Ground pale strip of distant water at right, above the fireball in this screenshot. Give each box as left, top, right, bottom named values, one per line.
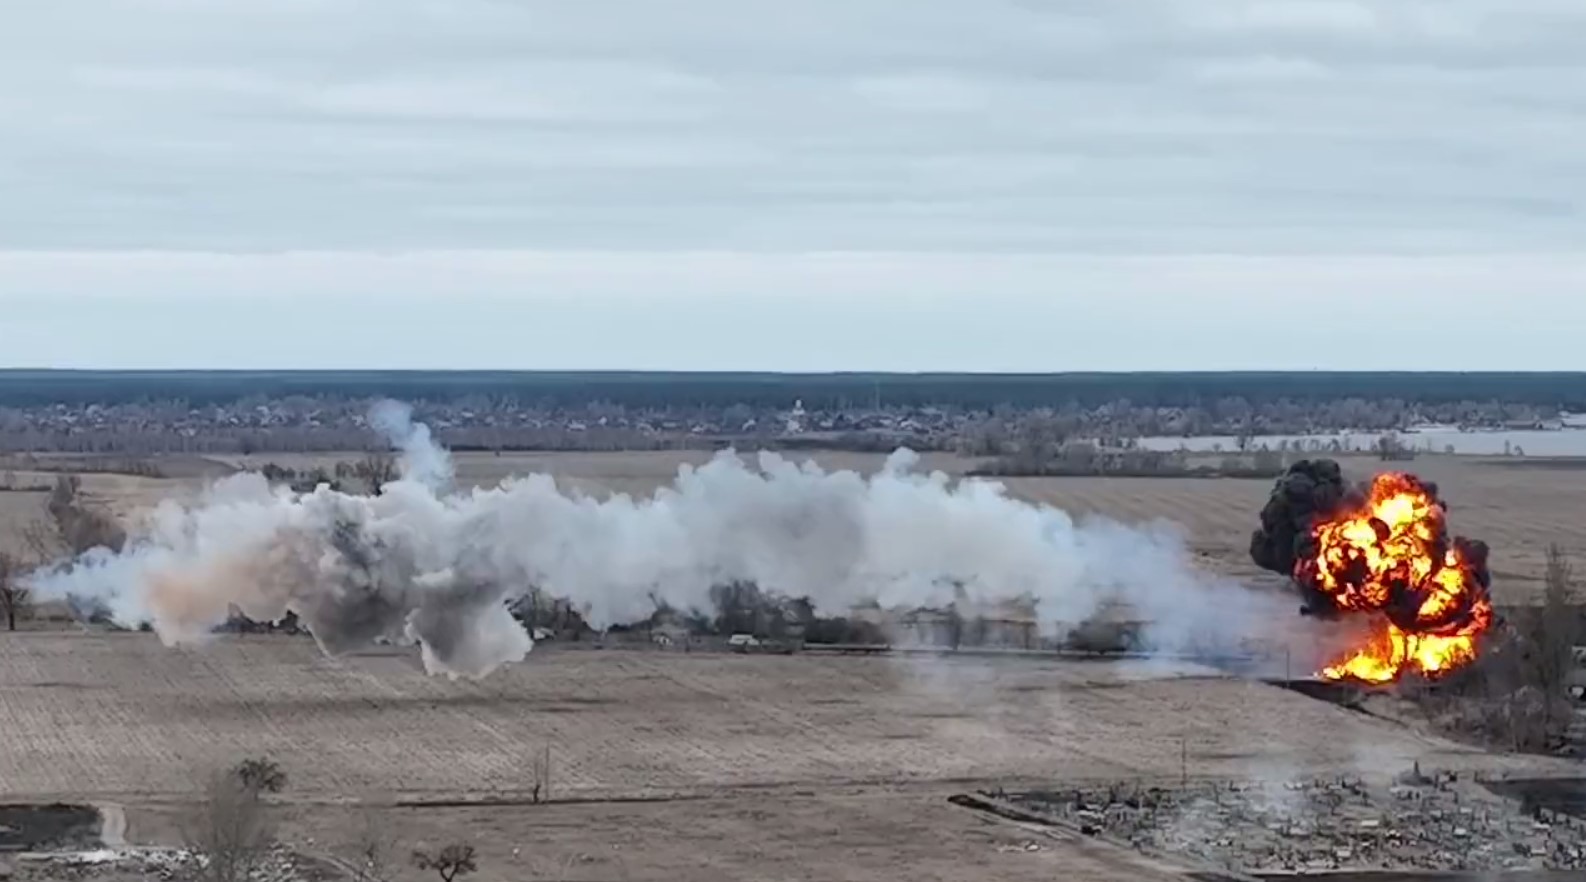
left=1139, top=428, right=1586, bottom=457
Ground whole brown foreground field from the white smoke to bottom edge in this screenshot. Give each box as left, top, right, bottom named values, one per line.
left=0, top=633, right=1562, bottom=882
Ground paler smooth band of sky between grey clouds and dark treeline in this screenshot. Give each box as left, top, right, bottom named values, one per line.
left=0, top=249, right=1586, bottom=371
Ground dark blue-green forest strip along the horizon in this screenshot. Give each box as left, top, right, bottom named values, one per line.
left=9, top=370, right=1586, bottom=411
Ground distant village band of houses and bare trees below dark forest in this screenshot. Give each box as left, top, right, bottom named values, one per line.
left=0, top=395, right=1565, bottom=457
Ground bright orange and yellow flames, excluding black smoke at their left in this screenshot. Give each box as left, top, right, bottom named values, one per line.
left=1296, top=473, right=1492, bottom=684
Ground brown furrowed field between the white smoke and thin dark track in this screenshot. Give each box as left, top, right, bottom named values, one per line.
left=0, top=633, right=1560, bottom=801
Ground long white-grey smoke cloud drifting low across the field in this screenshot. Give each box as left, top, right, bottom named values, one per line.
left=18, top=403, right=1293, bottom=676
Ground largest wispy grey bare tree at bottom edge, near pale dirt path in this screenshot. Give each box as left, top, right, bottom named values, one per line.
left=182, top=769, right=274, bottom=882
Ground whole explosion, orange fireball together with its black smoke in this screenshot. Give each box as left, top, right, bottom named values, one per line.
left=1251, top=460, right=1492, bottom=684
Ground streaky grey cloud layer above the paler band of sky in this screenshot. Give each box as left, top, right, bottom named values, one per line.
left=0, top=0, right=1586, bottom=252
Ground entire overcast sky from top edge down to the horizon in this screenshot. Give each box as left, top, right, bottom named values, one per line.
left=0, top=0, right=1586, bottom=371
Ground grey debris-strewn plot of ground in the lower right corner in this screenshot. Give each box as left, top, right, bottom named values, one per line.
left=1004, top=768, right=1586, bottom=874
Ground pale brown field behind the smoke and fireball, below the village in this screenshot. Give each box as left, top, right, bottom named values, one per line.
left=0, top=451, right=1586, bottom=603
